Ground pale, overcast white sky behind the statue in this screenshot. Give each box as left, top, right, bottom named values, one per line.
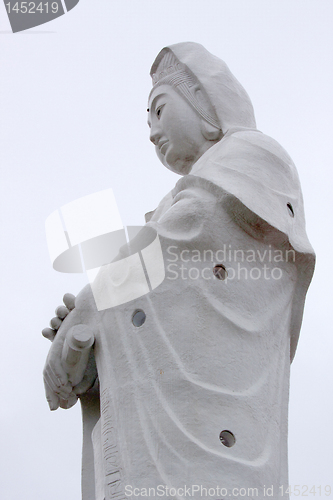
left=0, top=0, right=333, bottom=500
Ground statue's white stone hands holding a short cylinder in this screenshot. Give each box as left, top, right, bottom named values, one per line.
left=42, top=287, right=97, bottom=410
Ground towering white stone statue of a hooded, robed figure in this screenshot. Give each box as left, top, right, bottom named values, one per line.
left=44, top=43, right=314, bottom=500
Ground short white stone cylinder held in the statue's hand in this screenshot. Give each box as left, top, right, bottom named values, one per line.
left=62, top=325, right=95, bottom=387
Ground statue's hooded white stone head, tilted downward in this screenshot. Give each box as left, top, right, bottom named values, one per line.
left=148, top=43, right=255, bottom=175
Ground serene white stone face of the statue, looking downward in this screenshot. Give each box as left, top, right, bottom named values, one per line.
left=148, top=85, right=212, bottom=175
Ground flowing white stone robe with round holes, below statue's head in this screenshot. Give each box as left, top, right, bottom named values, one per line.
left=80, top=127, right=314, bottom=500
